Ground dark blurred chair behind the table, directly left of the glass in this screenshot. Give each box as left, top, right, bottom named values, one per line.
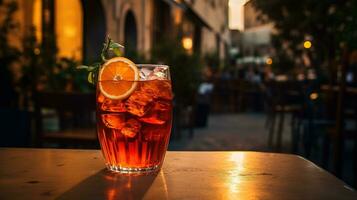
left=34, top=92, right=99, bottom=148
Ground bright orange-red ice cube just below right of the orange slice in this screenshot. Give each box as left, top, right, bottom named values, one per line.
left=125, top=90, right=153, bottom=117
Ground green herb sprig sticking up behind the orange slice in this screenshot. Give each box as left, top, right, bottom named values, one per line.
left=77, top=36, right=124, bottom=84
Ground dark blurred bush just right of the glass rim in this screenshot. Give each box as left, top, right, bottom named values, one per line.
left=150, top=39, right=202, bottom=105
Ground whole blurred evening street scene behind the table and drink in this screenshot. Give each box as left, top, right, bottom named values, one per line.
left=0, top=0, right=357, bottom=188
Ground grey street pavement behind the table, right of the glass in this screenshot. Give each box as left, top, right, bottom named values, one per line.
left=169, top=113, right=290, bottom=151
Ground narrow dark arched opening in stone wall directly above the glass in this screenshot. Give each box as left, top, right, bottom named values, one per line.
left=124, top=11, right=138, bottom=55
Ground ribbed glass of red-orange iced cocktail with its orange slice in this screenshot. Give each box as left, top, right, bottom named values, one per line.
left=97, top=57, right=172, bottom=173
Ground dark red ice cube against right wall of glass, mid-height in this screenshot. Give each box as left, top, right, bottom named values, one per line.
left=139, top=100, right=171, bottom=125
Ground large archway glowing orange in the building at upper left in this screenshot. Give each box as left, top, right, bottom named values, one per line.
left=32, top=0, right=106, bottom=63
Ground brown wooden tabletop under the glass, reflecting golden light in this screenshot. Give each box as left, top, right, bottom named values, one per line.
left=0, top=149, right=357, bottom=200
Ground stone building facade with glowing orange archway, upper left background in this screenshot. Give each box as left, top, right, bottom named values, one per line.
left=12, top=0, right=229, bottom=61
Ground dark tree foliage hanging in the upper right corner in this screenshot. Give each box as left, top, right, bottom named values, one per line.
left=252, top=0, right=357, bottom=80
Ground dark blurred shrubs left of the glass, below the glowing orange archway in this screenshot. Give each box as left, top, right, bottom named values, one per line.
left=20, top=28, right=91, bottom=93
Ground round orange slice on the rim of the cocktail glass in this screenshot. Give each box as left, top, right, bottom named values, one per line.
left=98, top=57, right=139, bottom=100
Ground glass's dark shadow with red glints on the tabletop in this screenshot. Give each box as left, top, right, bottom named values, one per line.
left=57, top=169, right=158, bottom=200
